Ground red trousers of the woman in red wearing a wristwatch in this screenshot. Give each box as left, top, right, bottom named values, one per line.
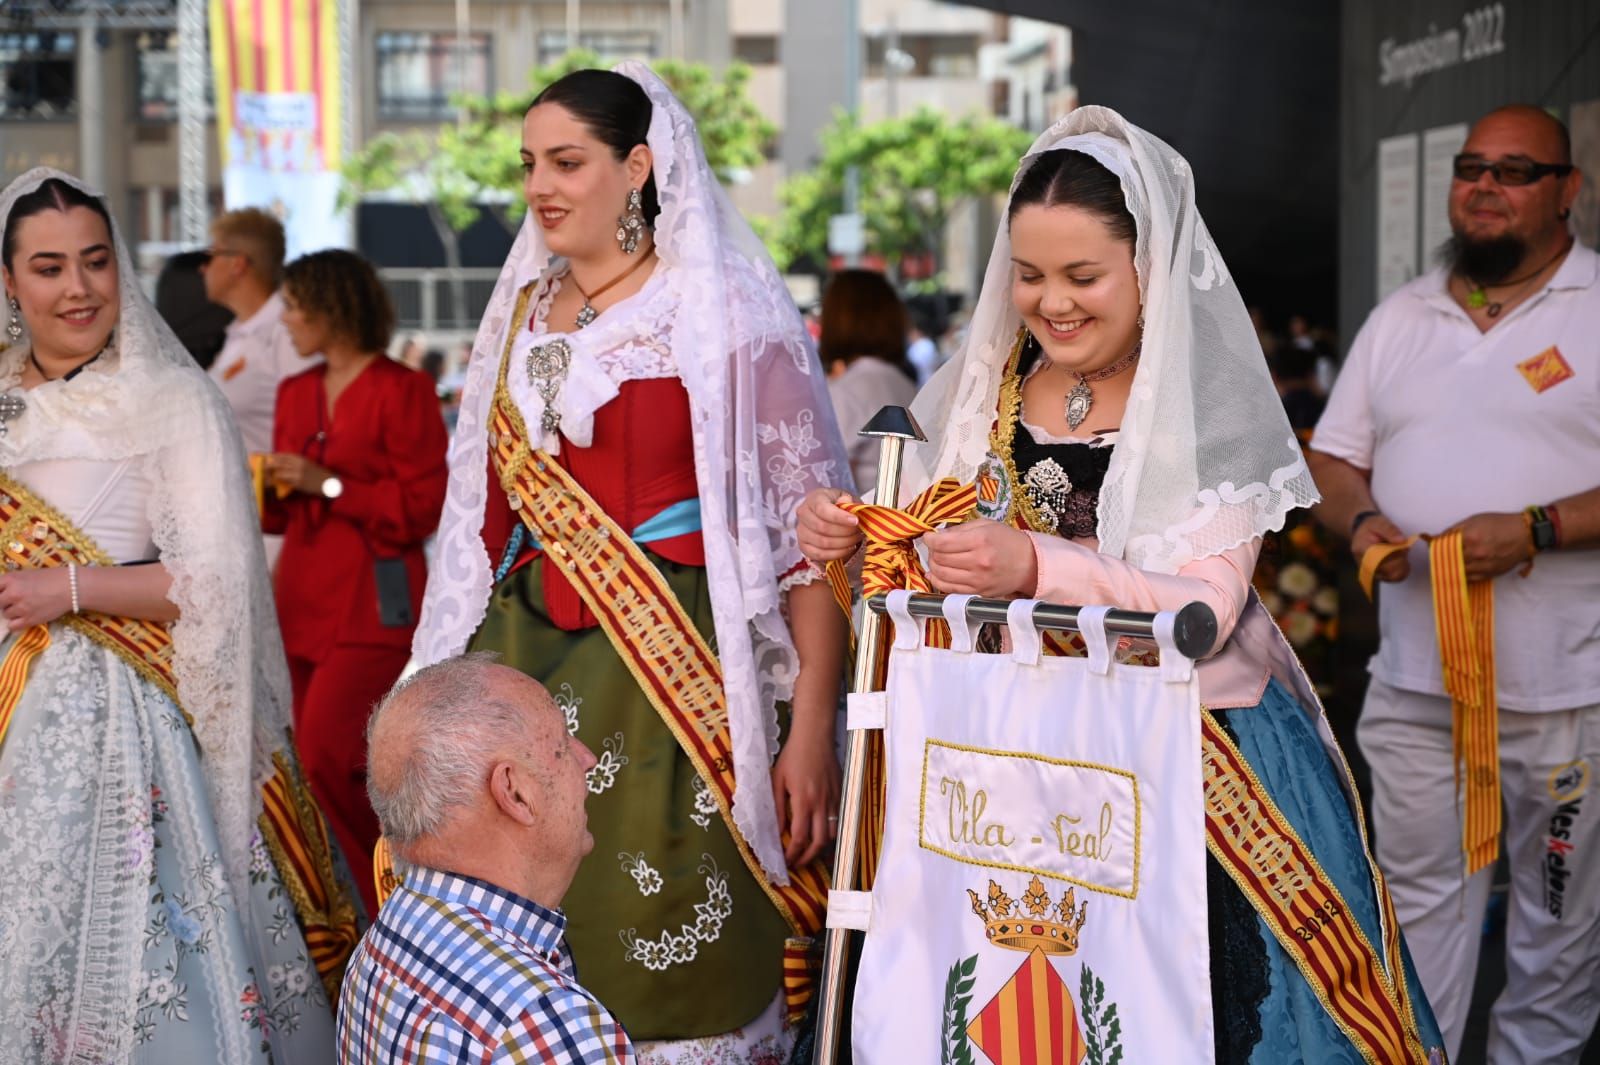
left=290, top=646, right=410, bottom=916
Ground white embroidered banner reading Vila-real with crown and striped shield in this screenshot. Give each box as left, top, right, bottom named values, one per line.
left=851, top=598, right=1213, bottom=1065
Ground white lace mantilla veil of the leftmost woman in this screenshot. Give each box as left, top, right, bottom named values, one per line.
left=0, top=168, right=290, bottom=914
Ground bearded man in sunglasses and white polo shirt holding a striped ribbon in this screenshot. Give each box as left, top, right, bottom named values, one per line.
left=1309, top=106, right=1600, bottom=1065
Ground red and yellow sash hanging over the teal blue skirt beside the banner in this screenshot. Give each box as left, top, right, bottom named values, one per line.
left=1200, top=713, right=1427, bottom=1065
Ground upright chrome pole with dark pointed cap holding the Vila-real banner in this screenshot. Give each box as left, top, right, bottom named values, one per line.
left=811, top=406, right=926, bottom=1065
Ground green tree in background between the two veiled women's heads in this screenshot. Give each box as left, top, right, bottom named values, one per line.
left=762, top=107, right=1032, bottom=269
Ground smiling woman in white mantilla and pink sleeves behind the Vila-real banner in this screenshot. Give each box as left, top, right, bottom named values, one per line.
left=800, top=107, right=1440, bottom=1065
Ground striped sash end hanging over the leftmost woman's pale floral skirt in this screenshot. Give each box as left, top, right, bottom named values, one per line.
left=256, top=741, right=362, bottom=1001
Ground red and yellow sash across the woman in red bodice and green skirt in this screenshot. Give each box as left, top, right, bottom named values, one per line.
left=490, top=289, right=827, bottom=1014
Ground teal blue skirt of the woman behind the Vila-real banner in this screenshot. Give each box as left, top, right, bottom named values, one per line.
left=1206, top=680, right=1445, bottom=1065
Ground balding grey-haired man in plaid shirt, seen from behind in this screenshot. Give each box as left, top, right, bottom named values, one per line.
left=339, top=656, right=635, bottom=1065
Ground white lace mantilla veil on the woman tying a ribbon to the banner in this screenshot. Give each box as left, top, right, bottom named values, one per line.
left=902, top=107, right=1318, bottom=572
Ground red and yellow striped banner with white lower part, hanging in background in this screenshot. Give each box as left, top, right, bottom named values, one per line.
left=210, top=0, right=347, bottom=252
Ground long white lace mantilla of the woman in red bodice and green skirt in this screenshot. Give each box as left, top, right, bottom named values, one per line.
left=413, top=61, right=850, bottom=883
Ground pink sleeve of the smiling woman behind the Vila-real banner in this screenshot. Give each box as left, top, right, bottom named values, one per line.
left=1029, top=533, right=1261, bottom=657
